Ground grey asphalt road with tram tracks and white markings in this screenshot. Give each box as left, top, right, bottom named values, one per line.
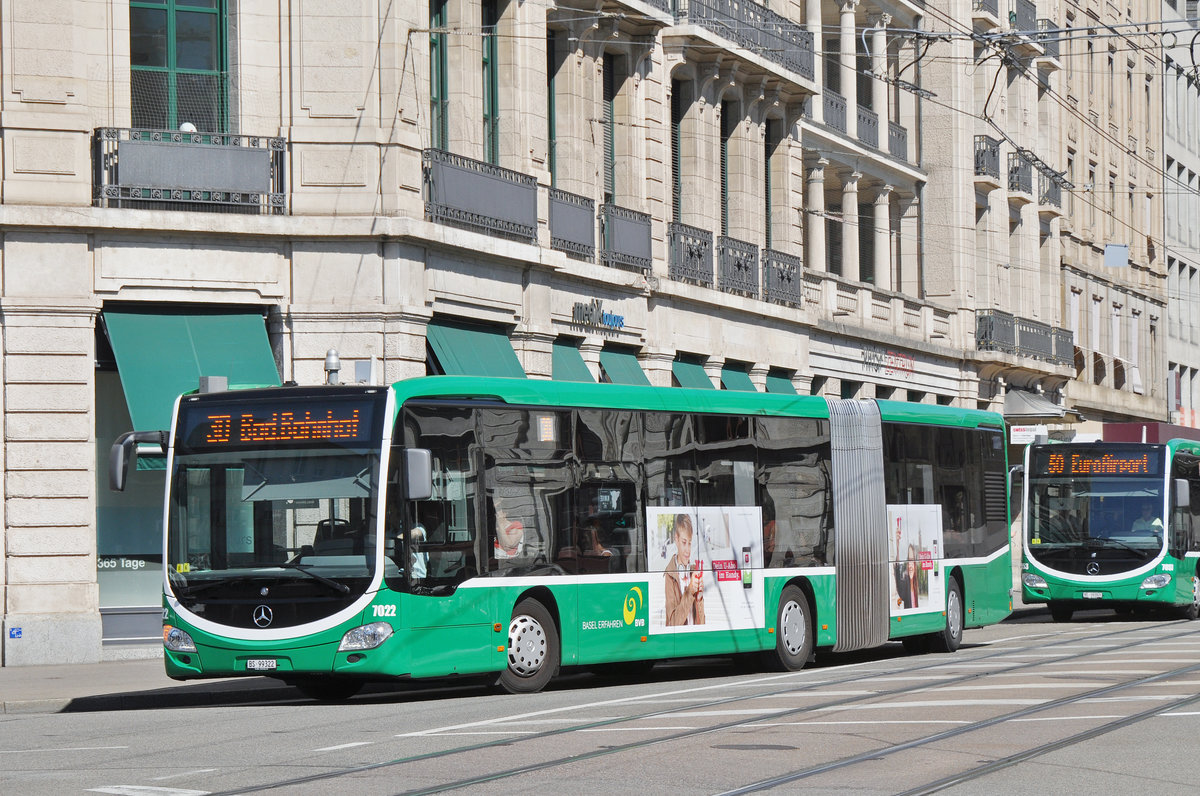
left=0, top=612, right=1200, bottom=796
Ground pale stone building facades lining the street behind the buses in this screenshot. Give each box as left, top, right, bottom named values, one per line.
left=0, top=0, right=1164, bottom=665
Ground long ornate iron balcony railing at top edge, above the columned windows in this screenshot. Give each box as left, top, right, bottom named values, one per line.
left=673, top=0, right=816, bottom=80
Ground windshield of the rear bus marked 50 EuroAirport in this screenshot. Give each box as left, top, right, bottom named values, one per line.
left=1025, top=445, right=1165, bottom=573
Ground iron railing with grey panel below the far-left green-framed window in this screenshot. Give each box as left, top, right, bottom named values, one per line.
left=91, top=127, right=287, bottom=215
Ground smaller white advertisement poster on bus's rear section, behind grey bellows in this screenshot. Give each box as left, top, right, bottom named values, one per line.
left=888, top=504, right=946, bottom=616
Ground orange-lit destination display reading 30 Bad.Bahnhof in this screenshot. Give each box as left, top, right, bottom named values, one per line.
left=181, top=401, right=374, bottom=450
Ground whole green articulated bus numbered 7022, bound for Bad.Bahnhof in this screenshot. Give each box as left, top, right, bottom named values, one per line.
left=112, top=376, right=1012, bottom=699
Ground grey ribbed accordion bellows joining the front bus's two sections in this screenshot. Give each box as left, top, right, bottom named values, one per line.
left=827, top=399, right=890, bottom=652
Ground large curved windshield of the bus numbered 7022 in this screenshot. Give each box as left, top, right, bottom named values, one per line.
left=166, top=395, right=379, bottom=628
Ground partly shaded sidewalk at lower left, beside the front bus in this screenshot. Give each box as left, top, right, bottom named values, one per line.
left=0, top=654, right=302, bottom=713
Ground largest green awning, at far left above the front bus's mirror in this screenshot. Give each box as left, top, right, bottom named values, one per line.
left=103, top=305, right=280, bottom=431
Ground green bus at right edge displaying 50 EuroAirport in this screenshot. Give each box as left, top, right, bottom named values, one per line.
left=1021, top=424, right=1200, bottom=622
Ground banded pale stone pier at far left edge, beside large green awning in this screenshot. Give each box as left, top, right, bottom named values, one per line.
left=0, top=298, right=102, bottom=666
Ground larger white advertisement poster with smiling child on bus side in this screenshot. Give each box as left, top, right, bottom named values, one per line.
left=646, top=505, right=764, bottom=633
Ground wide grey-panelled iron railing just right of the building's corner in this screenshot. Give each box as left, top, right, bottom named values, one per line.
left=422, top=149, right=538, bottom=243
